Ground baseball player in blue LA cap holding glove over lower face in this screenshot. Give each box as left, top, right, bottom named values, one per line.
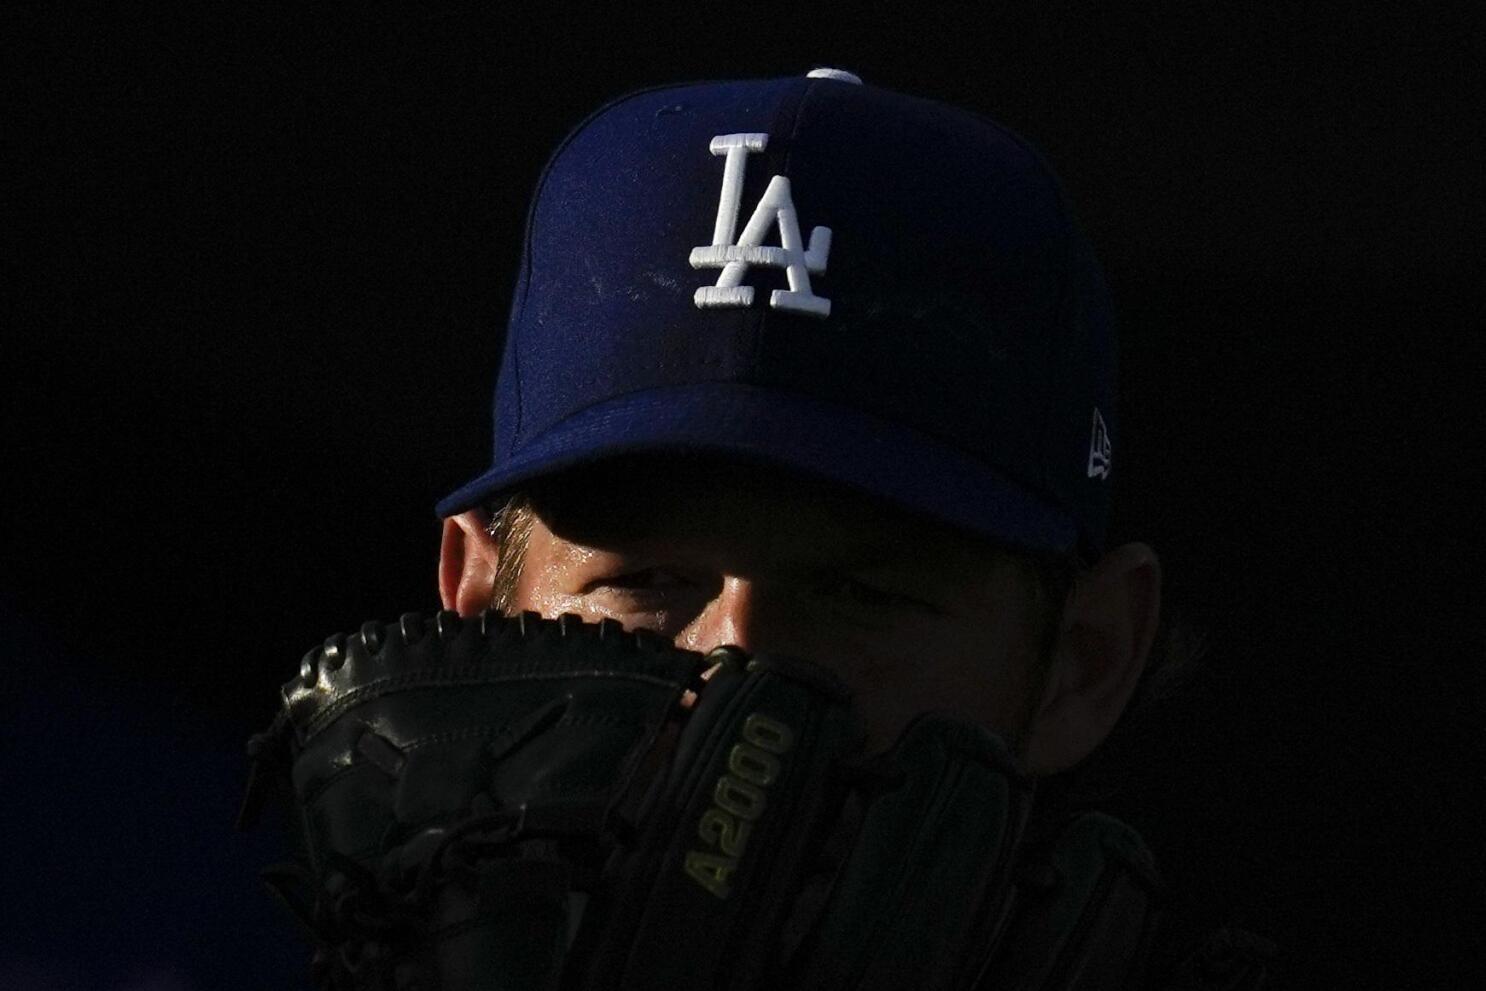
left=237, top=68, right=1265, bottom=988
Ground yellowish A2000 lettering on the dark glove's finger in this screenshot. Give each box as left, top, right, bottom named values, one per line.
left=687, top=712, right=795, bottom=899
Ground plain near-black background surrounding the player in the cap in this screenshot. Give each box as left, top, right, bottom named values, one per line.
left=0, top=0, right=1483, bottom=991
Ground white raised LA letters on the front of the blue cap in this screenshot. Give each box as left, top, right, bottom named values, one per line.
left=691, top=134, right=831, bottom=316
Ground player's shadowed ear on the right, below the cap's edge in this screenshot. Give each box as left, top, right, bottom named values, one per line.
left=1024, top=544, right=1161, bottom=774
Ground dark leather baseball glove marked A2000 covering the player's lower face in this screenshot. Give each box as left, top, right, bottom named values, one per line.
left=241, top=612, right=1262, bottom=991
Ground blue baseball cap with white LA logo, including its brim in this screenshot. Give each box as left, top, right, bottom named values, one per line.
left=438, top=70, right=1116, bottom=560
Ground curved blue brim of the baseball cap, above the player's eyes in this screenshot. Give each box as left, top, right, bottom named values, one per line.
left=437, top=383, right=1077, bottom=553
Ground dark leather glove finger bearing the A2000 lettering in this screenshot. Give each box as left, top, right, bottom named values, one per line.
left=574, top=657, right=862, bottom=990
